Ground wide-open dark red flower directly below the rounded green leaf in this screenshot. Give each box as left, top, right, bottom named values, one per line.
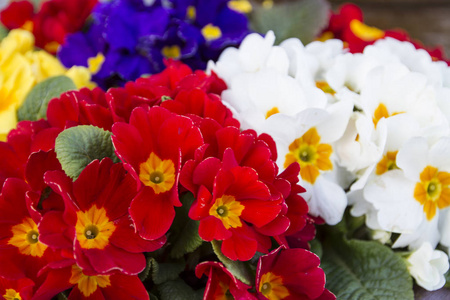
left=39, top=158, right=165, bottom=275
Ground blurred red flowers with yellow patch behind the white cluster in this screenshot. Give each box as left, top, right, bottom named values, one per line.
left=321, top=4, right=450, bottom=64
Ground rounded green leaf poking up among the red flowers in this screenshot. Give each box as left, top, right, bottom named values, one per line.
left=55, top=125, right=119, bottom=180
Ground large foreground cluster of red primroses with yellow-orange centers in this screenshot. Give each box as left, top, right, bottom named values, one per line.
left=0, top=62, right=335, bottom=300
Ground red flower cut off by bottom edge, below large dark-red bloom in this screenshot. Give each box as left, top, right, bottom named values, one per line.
left=33, top=264, right=149, bottom=300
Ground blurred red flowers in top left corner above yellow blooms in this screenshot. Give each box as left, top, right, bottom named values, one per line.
left=0, top=0, right=98, bottom=54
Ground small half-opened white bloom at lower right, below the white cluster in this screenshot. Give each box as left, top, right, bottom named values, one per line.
left=407, top=243, right=449, bottom=291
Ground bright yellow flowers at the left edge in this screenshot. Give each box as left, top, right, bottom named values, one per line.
left=0, top=29, right=95, bottom=141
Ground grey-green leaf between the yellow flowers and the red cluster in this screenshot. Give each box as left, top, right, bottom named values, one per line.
left=17, top=76, right=77, bottom=121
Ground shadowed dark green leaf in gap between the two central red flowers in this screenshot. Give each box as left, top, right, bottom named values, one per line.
left=169, top=193, right=203, bottom=258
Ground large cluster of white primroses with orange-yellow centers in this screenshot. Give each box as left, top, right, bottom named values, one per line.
left=208, top=32, right=450, bottom=289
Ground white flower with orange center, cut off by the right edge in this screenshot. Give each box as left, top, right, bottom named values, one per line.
left=364, top=137, right=450, bottom=248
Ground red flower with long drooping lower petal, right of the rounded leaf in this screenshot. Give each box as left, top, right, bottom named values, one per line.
left=112, top=107, right=203, bottom=239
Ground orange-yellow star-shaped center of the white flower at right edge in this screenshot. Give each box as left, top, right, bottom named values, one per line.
left=414, top=166, right=450, bottom=221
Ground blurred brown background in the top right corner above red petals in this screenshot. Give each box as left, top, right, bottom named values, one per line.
left=328, top=0, right=450, bottom=57
